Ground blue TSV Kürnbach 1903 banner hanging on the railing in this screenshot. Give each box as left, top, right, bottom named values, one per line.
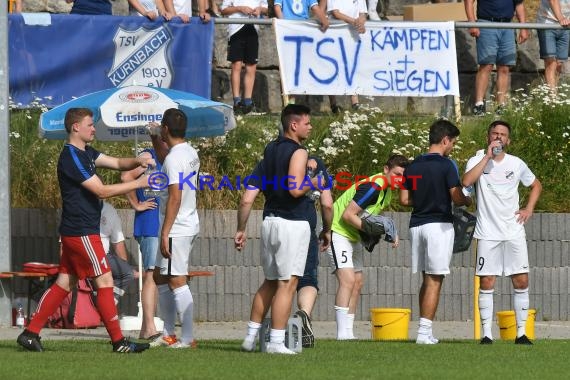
left=8, top=14, right=214, bottom=107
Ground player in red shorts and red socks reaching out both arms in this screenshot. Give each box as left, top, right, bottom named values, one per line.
left=17, top=108, right=154, bottom=353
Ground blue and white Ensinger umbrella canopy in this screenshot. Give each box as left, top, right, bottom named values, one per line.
left=39, top=86, right=236, bottom=141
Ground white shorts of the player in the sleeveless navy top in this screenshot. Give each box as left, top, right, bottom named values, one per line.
left=261, top=216, right=311, bottom=280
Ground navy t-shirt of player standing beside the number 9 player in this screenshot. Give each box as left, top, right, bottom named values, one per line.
left=404, top=153, right=461, bottom=227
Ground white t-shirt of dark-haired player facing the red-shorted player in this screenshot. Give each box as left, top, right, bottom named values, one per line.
left=159, top=143, right=200, bottom=237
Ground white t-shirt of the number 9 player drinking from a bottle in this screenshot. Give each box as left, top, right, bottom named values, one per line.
left=465, top=150, right=536, bottom=240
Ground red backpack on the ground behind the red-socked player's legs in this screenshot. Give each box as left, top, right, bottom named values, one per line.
left=47, top=280, right=101, bottom=329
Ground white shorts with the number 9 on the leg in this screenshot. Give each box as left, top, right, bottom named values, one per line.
left=475, top=238, right=529, bottom=276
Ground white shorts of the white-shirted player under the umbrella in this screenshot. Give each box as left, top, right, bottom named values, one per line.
left=155, top=235, right=196, bottom=276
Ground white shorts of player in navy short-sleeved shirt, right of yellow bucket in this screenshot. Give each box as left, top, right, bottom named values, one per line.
left=410, top=223, right=455, bottom=275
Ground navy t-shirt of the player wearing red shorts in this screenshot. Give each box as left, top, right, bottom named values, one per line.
left=57, top=144, right=103, bottom=236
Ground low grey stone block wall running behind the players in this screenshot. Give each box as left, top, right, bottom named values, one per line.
left=8, top=209, right=570, bottom=321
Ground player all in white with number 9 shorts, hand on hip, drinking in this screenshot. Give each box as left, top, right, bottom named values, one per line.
left=462, top=120, right=542, bottom=344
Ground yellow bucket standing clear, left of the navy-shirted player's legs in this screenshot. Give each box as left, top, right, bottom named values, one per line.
left=370, top=309, right=412, bottom=340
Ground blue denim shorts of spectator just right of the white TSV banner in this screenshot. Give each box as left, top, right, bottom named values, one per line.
left=477, top=20, right=517, bottom=66
